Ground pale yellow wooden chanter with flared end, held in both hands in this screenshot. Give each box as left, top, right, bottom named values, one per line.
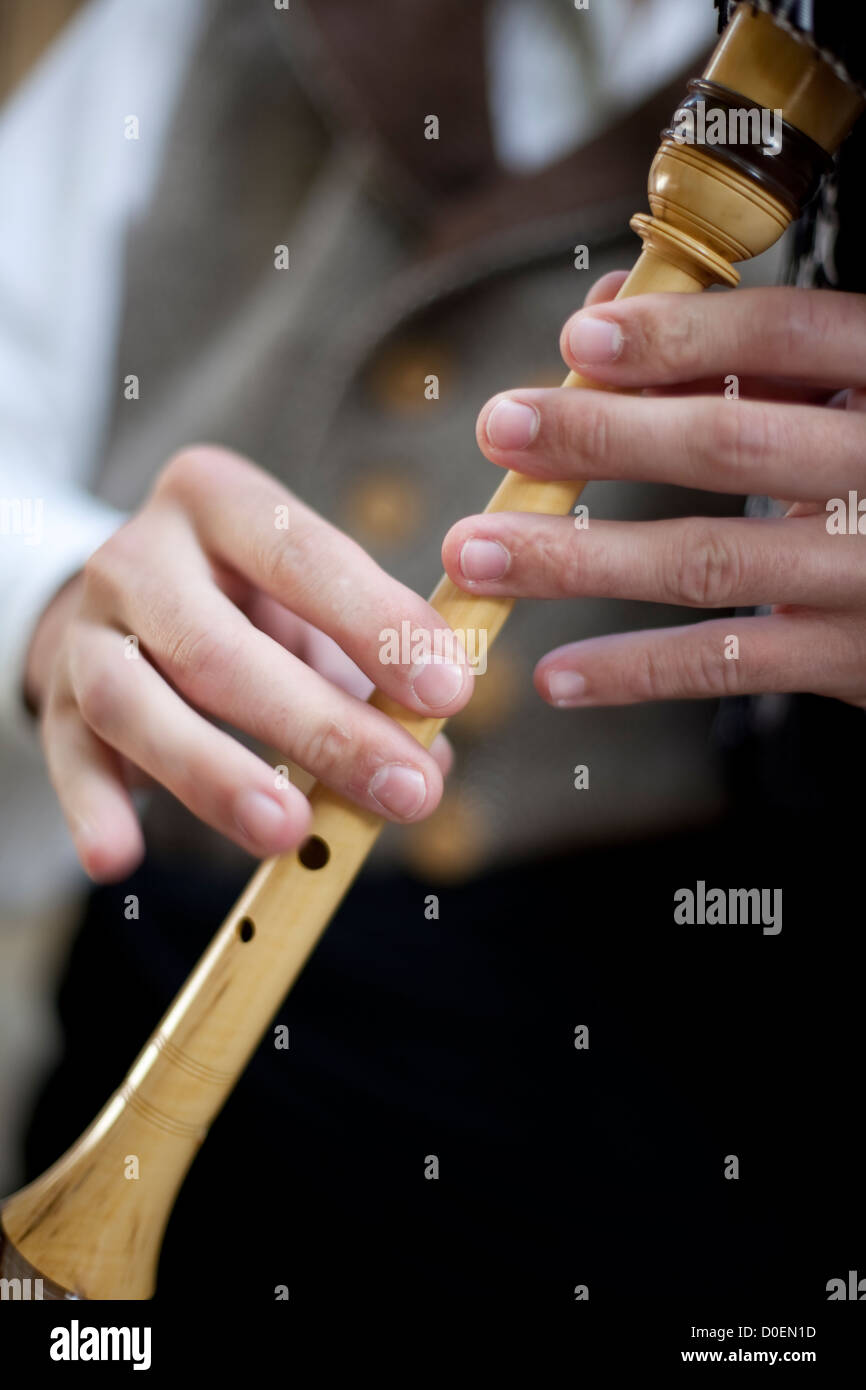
left=0, top=3, right=865, bottom=1298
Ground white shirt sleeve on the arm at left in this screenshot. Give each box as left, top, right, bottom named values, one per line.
left=0, top=0, right=207, bottom=910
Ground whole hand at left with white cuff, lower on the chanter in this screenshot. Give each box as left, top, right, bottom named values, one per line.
left=25, top=446, right=473, bottom=881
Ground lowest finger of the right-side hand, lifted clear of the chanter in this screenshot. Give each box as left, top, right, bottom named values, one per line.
left=534, top=612, right=866, bottom=709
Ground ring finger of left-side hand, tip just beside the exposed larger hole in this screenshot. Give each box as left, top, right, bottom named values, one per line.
left=70, top=627, right=310, bottom=858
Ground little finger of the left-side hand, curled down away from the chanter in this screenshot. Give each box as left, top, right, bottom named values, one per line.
left=42, top=696, right=145, bottom=883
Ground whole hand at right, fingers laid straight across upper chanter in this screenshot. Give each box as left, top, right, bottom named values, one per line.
left=442, top=272, right=866, bottom=706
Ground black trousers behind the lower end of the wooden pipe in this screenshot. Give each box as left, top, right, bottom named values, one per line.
left=26, top=816, right=863, bottom=1309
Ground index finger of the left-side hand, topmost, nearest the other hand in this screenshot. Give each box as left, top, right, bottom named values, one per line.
left=155, top=448, right=473, bottom=716
